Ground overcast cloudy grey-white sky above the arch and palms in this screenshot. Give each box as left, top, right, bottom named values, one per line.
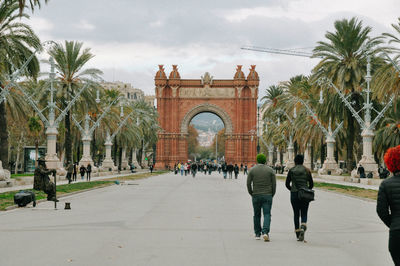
left=24, top=0, right=400, bottom=97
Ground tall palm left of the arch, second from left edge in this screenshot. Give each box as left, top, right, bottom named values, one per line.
left=49, top=41, right=102, bottom=161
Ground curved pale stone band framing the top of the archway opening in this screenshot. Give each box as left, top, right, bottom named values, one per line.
left=181, top=103, right=233, bottom=135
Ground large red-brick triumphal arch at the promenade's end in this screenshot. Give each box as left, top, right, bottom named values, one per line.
left=155, top=65, right=259, bottom=169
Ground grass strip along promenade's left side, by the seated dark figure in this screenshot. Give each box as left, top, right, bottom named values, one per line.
left=0, top=171, right=168, bottom=211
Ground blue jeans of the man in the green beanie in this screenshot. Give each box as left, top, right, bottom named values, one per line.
left=252, top=195, right=272, bottom=236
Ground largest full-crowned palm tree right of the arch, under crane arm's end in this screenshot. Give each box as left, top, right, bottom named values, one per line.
left=313, top=18, right=383, bottom=171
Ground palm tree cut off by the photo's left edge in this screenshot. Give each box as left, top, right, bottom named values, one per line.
left=0, top=1, right=41, bottom=169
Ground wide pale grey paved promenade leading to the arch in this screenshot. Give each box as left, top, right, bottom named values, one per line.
left=0, top=171, right=393, bottom=266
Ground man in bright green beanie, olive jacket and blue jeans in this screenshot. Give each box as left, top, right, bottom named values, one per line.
left=247, top=153, right=276, bottom=242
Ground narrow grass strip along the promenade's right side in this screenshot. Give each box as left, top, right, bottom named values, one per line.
left=277, top=177, right=378, bottom=200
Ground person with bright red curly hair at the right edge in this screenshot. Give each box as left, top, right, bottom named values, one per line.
left=376, top=145, right=400, bottom=266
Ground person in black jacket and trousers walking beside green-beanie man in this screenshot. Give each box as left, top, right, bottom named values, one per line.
left=285, top=154, right=314, bottom=241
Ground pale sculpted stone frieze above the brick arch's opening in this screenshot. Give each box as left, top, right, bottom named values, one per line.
left=179, top=86, right=235, bottom=98
